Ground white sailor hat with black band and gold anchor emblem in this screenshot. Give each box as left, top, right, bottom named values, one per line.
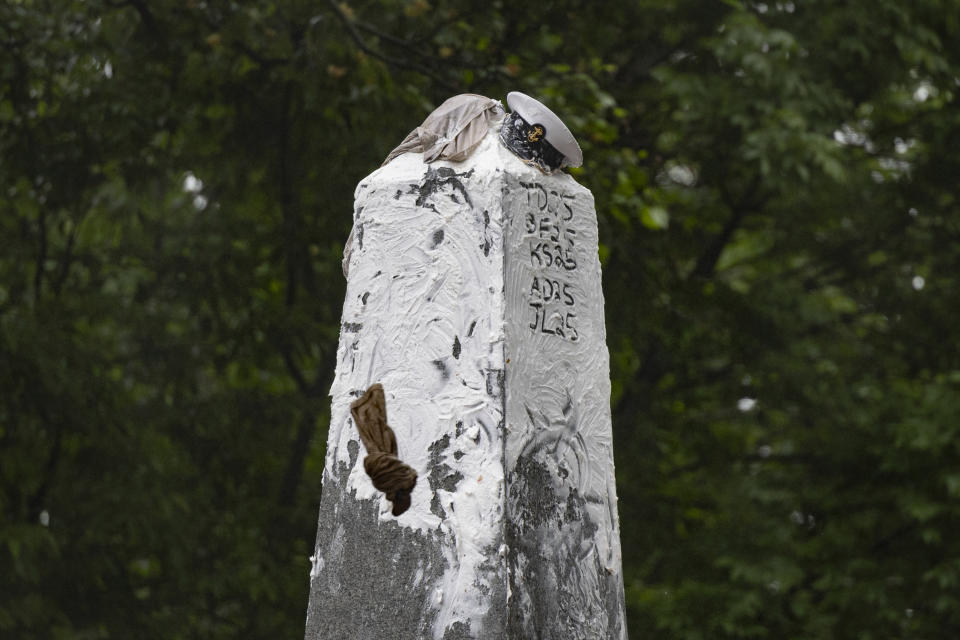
left=500, top=91, right=583, bottom=173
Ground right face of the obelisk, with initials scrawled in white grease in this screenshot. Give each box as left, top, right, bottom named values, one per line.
left=502, top=172, right=626, bottom=640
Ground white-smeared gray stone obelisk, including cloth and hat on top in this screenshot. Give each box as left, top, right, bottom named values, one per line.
left=306, top=93, right=626, bottom=640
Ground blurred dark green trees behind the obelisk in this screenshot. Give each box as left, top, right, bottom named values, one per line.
left=0, top=0, right=960, bottom=640
